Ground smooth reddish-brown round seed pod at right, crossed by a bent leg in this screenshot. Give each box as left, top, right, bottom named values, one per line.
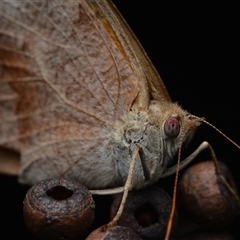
left=178, top=161, right=240, bottom=228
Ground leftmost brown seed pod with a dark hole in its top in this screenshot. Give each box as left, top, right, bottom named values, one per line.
left=23, top=178, right=95, bottom=240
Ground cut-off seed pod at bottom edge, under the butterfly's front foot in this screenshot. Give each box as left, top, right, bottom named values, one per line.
left=86, top=226, right=141, bottom=240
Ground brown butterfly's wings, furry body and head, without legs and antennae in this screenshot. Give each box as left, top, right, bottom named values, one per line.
left=0, top=1, right=204, bottom=189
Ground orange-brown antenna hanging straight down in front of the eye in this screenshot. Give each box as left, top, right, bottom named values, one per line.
left=165, top=131, right=183, bottom=240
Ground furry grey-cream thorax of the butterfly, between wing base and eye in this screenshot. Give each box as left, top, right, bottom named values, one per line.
left=113, top=101, right=180, bottom=189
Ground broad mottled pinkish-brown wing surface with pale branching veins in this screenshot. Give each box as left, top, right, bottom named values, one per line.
left=0, top=1, right=139, bottom=188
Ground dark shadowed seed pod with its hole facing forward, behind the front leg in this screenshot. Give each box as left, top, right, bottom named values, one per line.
left=110, top=187, right=176, bottom=240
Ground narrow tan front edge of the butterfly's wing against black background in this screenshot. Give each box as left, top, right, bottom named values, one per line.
left=89, top=0, right=171, bottom=110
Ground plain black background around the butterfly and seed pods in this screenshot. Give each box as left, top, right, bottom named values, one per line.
left=0, top=0, right=240, bottom=239
